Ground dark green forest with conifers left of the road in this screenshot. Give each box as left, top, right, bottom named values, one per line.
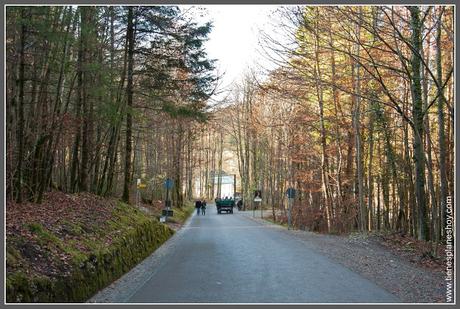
left=6, top=6, right=216, bottom=205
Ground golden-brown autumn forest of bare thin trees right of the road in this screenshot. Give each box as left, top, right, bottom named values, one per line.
left=215, top=6, right=454, bottom=243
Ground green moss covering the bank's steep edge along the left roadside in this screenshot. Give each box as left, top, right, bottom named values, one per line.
left=6, top=203, right=174, bottom=302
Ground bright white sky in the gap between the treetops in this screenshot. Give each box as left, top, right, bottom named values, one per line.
left=185, top=5, right=276, bottom=100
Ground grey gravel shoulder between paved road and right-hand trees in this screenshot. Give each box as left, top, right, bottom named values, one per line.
left=238, top=212, right=446, bottom=303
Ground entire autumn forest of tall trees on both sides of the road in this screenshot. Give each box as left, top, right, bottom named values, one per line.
left=5, top=6, right=455, bottom=243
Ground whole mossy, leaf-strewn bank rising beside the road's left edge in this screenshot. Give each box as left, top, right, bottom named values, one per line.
left=6, top=194, right=181, bottom=303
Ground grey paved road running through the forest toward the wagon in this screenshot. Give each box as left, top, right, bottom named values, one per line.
left=94, top=206, right=399, bottom=303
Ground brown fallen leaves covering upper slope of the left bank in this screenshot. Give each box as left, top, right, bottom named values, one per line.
left=6, top=191, right=124, bottom=277
